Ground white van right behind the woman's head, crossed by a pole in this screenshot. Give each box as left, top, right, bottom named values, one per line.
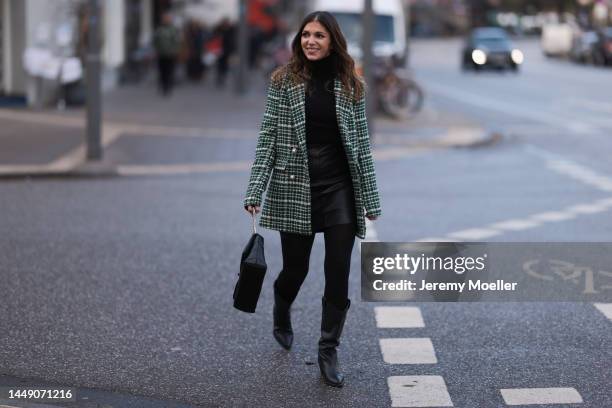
left=309, top=0, right=406, bottom=61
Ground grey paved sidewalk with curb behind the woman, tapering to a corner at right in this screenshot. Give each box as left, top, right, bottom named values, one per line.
left=0, top=76, right=496, bottom=178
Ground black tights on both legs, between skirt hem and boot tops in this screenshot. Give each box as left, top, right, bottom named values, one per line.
left=275, top=224, right=355, bottom=309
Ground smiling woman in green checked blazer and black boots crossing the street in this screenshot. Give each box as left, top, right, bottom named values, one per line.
left=244, top=11, right=381, bottom=387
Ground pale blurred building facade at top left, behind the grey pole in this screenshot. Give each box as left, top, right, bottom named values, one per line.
left=0, top=0, right=154, bottom=106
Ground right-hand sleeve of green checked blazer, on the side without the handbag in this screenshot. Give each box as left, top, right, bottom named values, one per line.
left=355, top=91, right=382, bottom=216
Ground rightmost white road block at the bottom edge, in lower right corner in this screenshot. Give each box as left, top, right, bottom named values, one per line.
left=500, top=388, right=584, bottom=405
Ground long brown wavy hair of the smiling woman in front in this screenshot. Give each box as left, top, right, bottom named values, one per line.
left=272, top=11, right=365, bottom=100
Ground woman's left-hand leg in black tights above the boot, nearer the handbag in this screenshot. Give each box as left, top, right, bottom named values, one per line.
left=275, top=232, right=314, bottom=303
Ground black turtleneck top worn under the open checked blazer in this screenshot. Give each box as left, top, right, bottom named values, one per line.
left=305, top=56, right=350, bottom=191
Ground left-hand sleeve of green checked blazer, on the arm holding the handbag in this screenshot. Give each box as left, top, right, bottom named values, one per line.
left=243, top=81, right=281, bottom=208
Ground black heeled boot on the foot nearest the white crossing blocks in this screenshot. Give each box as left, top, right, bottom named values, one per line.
left=318, top=298, right=351, bottom=387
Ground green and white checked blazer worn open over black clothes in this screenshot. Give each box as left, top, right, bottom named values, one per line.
left=244, top=74, right=381, bottom=239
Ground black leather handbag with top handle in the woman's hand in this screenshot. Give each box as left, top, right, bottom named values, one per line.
left=234, top=214, right=268, bottom=313
